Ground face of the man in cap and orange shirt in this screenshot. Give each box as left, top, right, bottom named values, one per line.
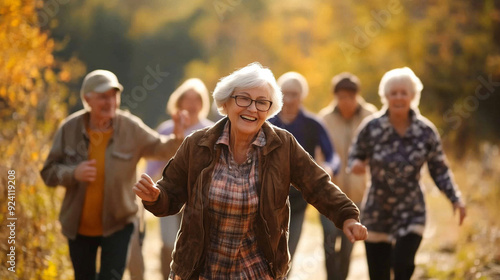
left=84, top=88, right=120, bottom=123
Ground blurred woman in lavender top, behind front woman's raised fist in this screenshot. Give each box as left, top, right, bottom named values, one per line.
left=146, top=78, right=214, bottom=279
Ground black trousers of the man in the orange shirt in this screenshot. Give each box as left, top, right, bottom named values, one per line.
left=68, top=223, right=134, bottom=280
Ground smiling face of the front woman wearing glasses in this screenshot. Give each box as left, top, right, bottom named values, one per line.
left=224, top=86, right=270, bottom=139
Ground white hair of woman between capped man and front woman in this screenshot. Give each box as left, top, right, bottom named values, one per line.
left=166, top=78, right=210, bottom=119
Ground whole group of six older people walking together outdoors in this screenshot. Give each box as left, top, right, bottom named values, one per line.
left=41, top=63, right=466, bottom=280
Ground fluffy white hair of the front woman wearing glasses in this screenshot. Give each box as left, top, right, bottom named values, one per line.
left=213, top=62, right=283, bottom=119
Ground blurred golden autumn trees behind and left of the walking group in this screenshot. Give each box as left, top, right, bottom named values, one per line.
left=0, top=0, right=500, bottom=279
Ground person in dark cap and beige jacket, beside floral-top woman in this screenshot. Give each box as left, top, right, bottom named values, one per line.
left=319, top=72, right=377, bottom=280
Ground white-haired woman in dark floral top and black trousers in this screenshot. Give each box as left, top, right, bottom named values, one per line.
left=349, top=67, right=466, bottom=280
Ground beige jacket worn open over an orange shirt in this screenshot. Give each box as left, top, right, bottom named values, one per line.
left=40, top=110, right=182, bottom=239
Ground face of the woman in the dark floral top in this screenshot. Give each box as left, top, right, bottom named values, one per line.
left=386, top=82, right=414, bottom=115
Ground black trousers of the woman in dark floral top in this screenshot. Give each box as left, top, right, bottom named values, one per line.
left=365, top=233, right=422, bottom=280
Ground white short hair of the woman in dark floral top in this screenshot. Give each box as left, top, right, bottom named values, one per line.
left=378, top=67, right=424, bottom=112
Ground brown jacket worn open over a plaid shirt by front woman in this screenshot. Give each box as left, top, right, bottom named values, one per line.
left=143, top=118, right=359, bottom=279
